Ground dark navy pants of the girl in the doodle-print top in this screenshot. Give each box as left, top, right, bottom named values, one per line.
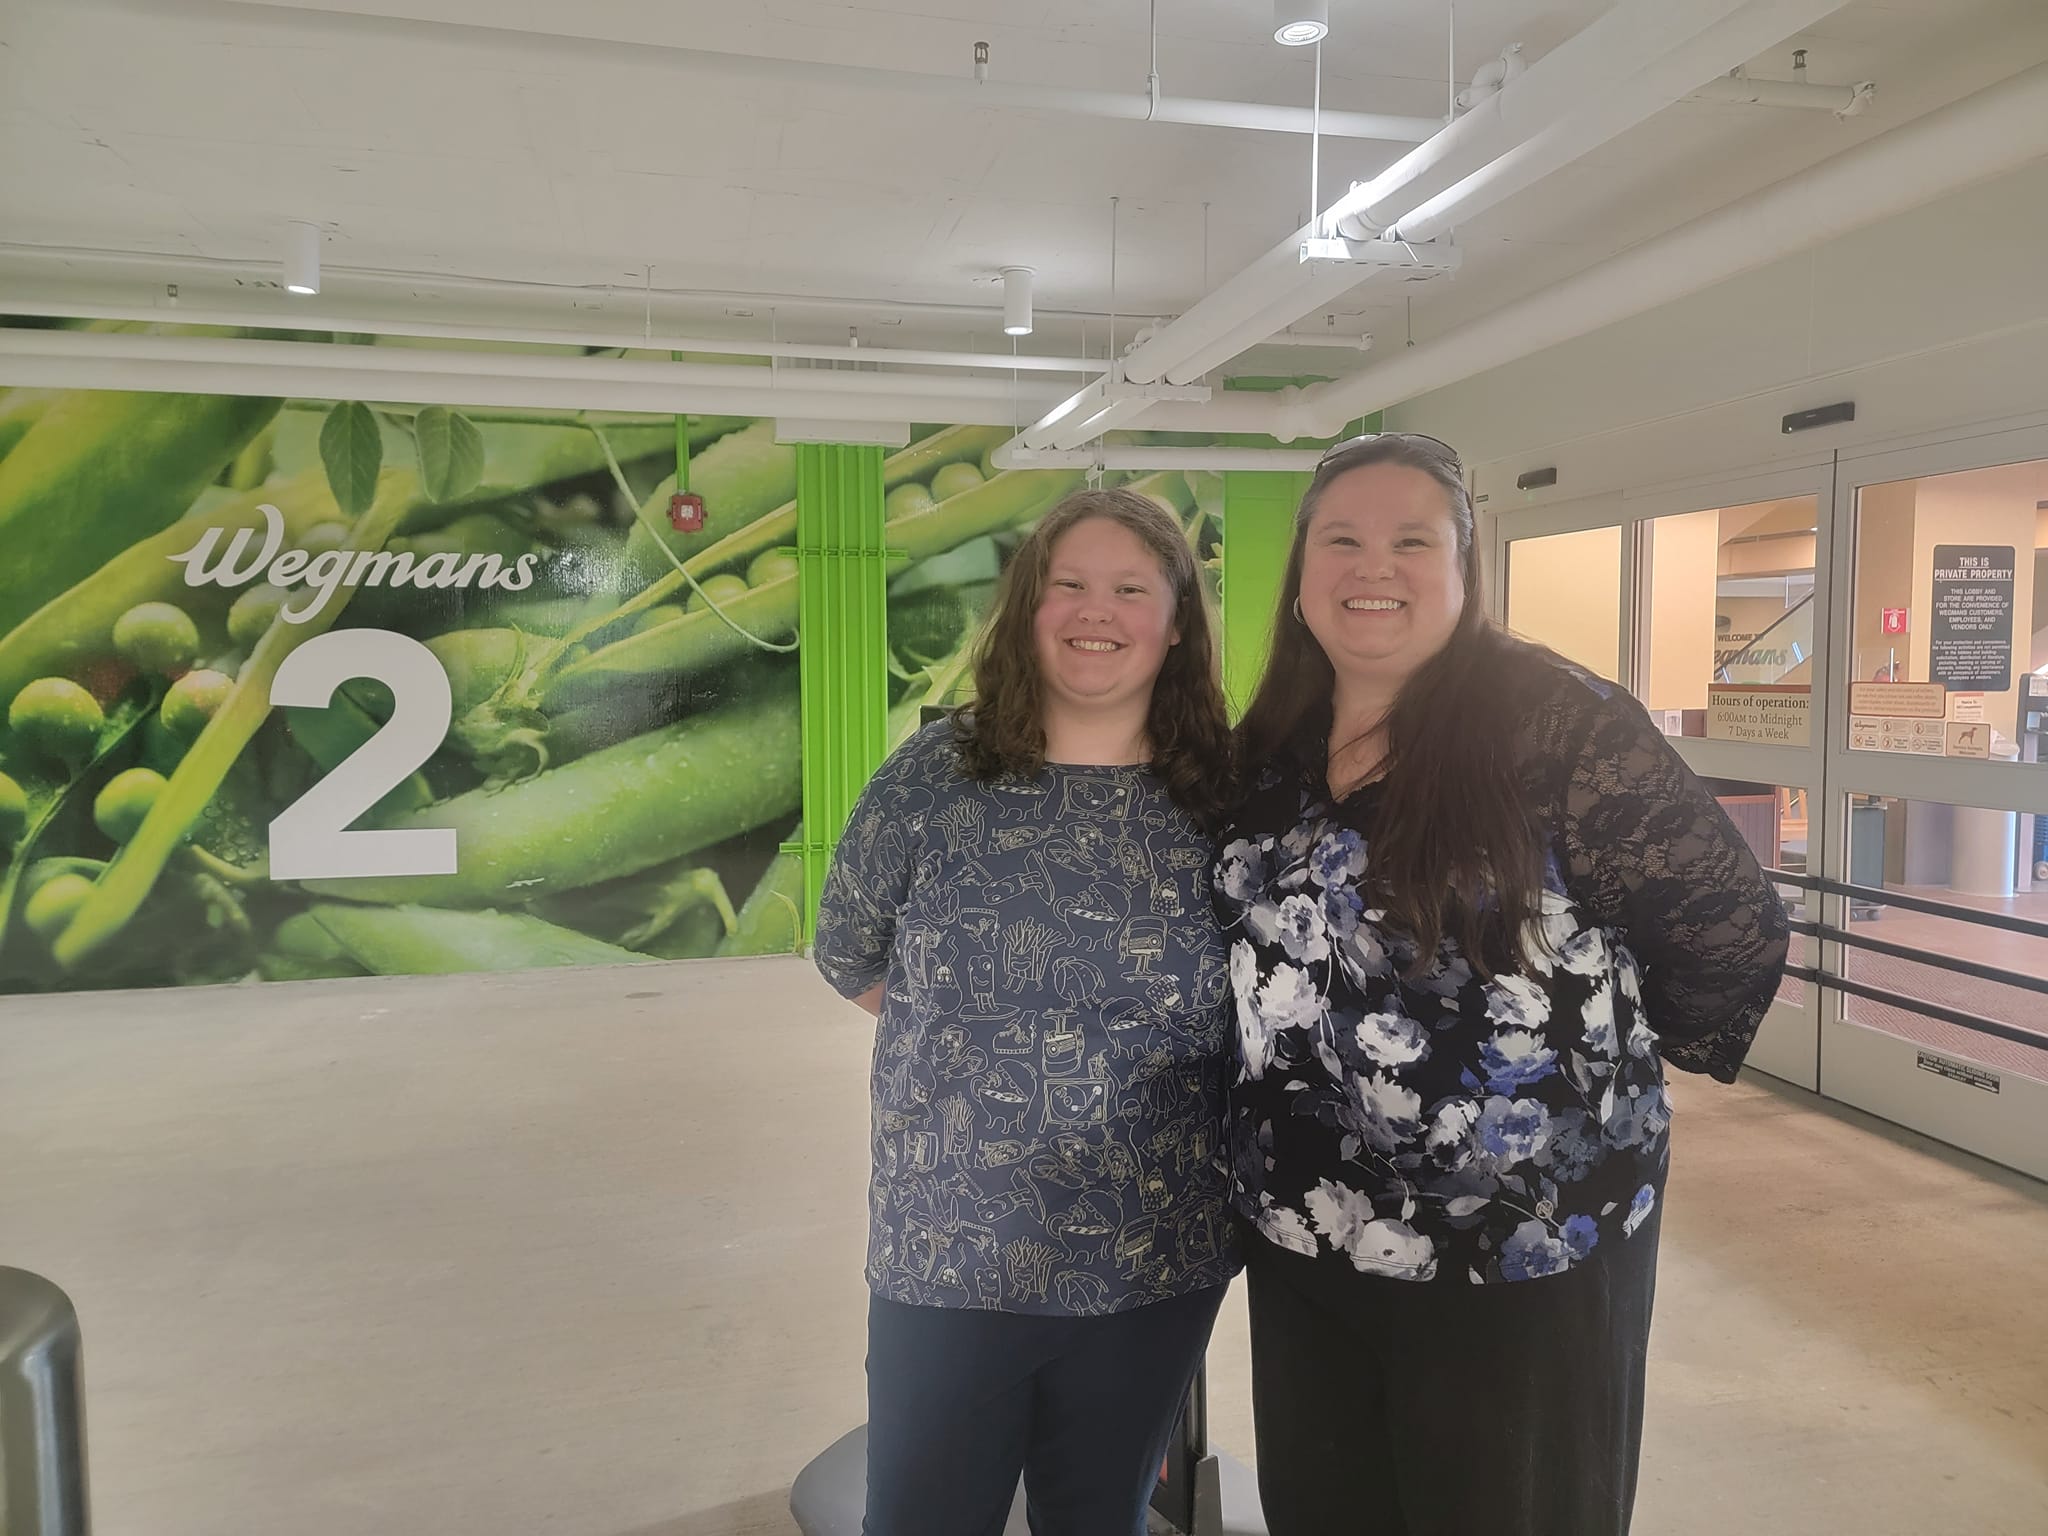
left=862, top=1286, right=1225, bottom=1536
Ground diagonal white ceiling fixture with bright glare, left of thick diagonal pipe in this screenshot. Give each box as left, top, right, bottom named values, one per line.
left=1124, top=0, right=1810, bottom=393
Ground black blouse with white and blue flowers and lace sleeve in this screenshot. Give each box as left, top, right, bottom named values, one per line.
left=1217, top=668, right=1788, bottom=1284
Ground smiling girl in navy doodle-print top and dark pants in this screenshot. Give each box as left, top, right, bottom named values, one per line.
left=815, top=489, right=1239, bottom=1536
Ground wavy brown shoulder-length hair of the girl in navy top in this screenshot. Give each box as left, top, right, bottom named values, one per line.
left=952, top=489, right=1231, bottom=827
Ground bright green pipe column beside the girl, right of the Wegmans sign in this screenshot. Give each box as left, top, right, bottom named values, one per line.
left=793, top=442, right=889, bottom=934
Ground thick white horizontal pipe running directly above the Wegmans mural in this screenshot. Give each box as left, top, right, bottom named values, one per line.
left=0, top=330, right=1073, bottom=410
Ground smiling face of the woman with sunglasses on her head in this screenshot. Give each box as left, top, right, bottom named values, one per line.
left=1300, top=463, right=1464, bottom=690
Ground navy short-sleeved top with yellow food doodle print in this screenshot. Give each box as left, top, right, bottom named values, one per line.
left=815, top=721, right=1239, bottom=1315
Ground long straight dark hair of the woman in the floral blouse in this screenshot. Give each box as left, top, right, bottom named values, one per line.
left=1237, top=434, right=1548, bottom=977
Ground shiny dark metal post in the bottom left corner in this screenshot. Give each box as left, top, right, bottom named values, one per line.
left=0, top=1268, right=92, bottom=1536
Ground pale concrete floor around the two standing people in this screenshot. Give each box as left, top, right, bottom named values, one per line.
left=0, top=961, right=2048, bottom=1536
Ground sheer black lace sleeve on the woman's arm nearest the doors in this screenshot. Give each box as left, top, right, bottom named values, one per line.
left=1538, top=678, right=1790, bottom=1081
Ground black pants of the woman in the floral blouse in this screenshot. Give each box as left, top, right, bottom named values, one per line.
left=1249, top=1217, right=1657, bottom=1536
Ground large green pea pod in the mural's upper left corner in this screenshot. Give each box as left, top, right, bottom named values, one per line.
left=0, top=389, right=283, bottom=629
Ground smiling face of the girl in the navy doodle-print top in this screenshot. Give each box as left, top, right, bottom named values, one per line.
left=1032, top=518, right=1180, bottom=717
